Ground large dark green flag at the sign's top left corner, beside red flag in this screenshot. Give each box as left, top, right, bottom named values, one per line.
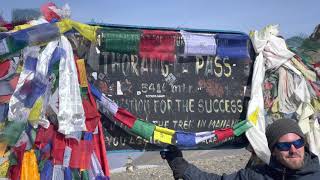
left=100, top=28, right=141, bottom=54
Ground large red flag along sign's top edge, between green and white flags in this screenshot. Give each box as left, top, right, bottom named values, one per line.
left=139, top=30, right=178, bottom=62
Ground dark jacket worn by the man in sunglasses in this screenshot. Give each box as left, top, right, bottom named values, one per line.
left=183, top=151, right=320, bottom=180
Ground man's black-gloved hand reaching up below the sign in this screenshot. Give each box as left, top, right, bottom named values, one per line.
left=160, top=145, right=188, bottom=179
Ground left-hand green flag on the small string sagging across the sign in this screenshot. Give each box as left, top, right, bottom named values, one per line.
left=131, top=119, right=156, bottom=140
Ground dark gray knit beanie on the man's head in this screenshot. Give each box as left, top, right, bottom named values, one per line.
left=266, top=119, right=305, bottom=151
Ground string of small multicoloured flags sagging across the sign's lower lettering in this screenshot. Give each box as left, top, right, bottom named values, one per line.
left=90, top=84, right=252, bottom=147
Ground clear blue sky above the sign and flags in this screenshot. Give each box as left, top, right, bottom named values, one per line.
left=0, top=0, right=320, bottom=38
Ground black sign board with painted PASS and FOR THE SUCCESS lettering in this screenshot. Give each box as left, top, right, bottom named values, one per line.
left=85, top=25, right=253, bottom=151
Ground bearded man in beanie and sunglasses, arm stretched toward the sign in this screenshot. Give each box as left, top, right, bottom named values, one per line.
left=165, top=119, right=320, bottom=180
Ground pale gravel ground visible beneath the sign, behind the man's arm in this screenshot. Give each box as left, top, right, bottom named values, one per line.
left=111, top=149, right=250, bottom=180
